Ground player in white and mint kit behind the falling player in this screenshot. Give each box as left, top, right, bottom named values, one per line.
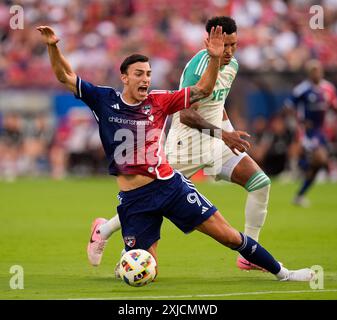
left=89, top=16, right=270, bottom=270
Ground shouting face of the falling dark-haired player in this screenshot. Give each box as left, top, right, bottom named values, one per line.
left=121, top=62, right=151, bottom=102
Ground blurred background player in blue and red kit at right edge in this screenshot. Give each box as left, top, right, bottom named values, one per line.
left=285, top=60, right=337, bottom=207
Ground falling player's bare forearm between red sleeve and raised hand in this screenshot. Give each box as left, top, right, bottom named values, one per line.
left=190, top=57, right=220, bottom=104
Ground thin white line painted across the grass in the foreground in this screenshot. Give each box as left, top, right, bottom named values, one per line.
left=69, top=289, right=337, bottom=300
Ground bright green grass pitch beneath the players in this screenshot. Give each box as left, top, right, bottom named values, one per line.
left=0, top=178, right=337, bottom=300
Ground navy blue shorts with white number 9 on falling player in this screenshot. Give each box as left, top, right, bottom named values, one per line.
left=117, top=171, right=217, bottom=251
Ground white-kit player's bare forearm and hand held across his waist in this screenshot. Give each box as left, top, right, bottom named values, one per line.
left=180, top=109, right=250, bottom=154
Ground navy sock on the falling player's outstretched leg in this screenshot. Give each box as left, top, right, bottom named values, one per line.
left=233, top=232, right=281, bottom=274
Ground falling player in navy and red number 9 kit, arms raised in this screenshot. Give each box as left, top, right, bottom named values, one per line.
left=37, top=26, right=314, bottom=281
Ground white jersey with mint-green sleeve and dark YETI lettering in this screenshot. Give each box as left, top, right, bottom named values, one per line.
left=166, top=49, right=238, bottom=166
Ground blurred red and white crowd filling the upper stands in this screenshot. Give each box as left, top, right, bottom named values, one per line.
left=0, top=0, right=337, bottom=89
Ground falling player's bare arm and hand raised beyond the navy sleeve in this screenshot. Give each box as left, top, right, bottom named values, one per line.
left=36, top=26, right=77, bottom=94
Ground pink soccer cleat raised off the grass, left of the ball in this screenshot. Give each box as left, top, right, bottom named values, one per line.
left=87, top=218, right=108, bottom=267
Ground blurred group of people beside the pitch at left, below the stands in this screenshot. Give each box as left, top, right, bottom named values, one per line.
left=0, top=108, right=107, bottom=181
